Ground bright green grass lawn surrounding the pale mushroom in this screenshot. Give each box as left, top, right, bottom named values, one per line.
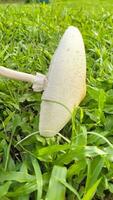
left=0, top=0, right=113, bottom=200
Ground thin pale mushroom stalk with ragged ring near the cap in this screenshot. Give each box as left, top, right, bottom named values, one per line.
left=0, top=66, right=47, bottom=92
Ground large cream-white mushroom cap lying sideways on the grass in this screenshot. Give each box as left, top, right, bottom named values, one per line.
left=39, top=26, right=86, bottom=137
